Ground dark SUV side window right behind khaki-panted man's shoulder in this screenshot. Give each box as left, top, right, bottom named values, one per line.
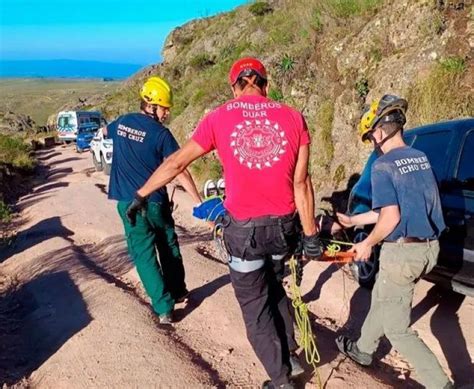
left=412, top=131, right=453, bottom=181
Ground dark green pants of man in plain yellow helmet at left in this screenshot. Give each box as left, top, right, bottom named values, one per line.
left=117, top=201, right=186, bottom=315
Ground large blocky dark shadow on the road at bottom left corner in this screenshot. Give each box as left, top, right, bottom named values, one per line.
left=0, top=271, right=91, bottom=387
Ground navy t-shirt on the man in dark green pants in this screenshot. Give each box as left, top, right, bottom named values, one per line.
left=107, top=113, right=179, bottom=202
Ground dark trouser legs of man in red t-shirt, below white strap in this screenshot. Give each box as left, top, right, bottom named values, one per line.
left=230, top=255, right=298, bottom=386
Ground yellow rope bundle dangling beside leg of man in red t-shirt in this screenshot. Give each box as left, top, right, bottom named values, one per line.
left=289, top=256, right=322, bottom=389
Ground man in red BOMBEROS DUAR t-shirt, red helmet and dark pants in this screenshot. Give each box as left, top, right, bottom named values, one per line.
left=129, top=58, right=321, bottom=388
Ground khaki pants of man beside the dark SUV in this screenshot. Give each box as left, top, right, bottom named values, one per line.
left=357, top=241, right=449, bottom=389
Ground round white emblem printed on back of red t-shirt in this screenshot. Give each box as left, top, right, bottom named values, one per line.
left=230, top=119, right=288, bottom=170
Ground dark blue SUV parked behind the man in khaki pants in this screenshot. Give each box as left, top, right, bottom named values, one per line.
left=348, top=118, right=474, bottom=296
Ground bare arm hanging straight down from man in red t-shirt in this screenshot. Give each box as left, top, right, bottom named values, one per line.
left=293, top=145, right=317, bottom=236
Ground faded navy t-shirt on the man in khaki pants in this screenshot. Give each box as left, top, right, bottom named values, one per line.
left=371, top=146, right=446, bottom=241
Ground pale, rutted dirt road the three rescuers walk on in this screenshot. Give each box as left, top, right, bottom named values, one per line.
left=0, top=147, right=474, bottom=389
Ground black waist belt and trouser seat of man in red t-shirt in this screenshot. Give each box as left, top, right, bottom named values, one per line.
left=221, top=213, right=301, bottom=261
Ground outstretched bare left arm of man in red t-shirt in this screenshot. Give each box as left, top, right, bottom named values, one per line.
left=137, top=139, right=205, bottom=197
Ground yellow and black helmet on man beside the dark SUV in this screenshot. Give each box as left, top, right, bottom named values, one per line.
left=359, top=95, right=408, bottom=143
